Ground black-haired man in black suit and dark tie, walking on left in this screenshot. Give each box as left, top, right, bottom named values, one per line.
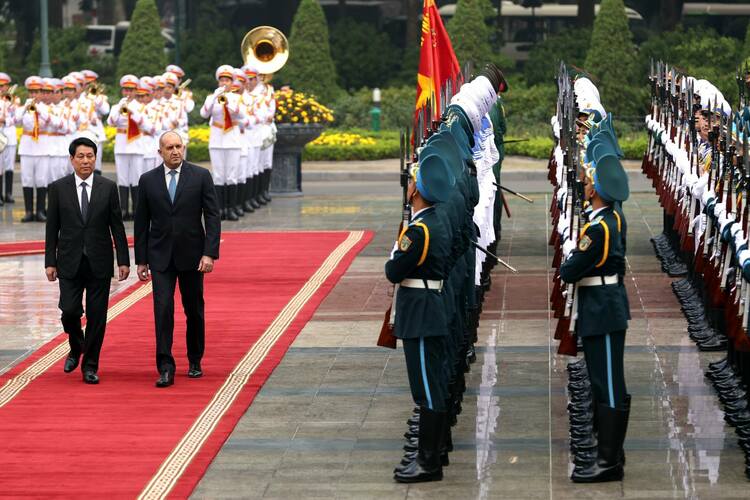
left=44, top=137, right=130, bottom=384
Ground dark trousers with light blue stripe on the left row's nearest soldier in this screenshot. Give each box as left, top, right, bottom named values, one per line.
left=402, top=337, right=450, bottom=411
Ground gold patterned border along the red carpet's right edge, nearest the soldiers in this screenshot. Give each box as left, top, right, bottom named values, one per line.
left=138, top=231, right=364, bottom=499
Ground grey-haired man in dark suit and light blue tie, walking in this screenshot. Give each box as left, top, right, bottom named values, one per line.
left=135, top=131, right=221, bottom=387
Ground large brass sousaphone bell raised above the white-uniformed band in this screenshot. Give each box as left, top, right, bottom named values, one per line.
left=240, top=26, right=289, bottom=82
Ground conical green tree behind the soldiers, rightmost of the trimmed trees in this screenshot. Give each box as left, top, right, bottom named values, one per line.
left=585, top=0, right=643, bottom=115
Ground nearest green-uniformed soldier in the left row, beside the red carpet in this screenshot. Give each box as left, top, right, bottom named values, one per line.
left=385, top=154, right=456, bottom=483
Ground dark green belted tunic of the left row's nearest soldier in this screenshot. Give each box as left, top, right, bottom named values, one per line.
left=385, top=207, right=451, bottom=339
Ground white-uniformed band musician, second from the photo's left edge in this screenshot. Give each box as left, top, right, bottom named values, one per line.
left=16, top=76, right=55, bottom=222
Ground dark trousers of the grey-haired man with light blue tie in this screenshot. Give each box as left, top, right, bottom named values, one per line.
left=151, top=263, right=206, bottom=373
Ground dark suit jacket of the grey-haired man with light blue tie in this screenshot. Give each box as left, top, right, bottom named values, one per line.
left=135, top=162, right=221, bottom=271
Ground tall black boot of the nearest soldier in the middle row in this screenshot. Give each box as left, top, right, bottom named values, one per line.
left=570, top=405, right=630, bottom=483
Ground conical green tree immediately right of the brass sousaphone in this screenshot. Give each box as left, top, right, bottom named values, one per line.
left=279, top=0, right=341, bottom=104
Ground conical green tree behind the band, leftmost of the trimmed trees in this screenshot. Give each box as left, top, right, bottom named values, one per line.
left=117, top=0, right=166, bottom=77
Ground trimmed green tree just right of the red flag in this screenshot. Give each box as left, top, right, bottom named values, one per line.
left=446, top=0, right=492, bottom=68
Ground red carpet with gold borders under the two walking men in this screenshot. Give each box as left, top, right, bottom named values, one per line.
left=0, top=231, right=372, bottom=498
